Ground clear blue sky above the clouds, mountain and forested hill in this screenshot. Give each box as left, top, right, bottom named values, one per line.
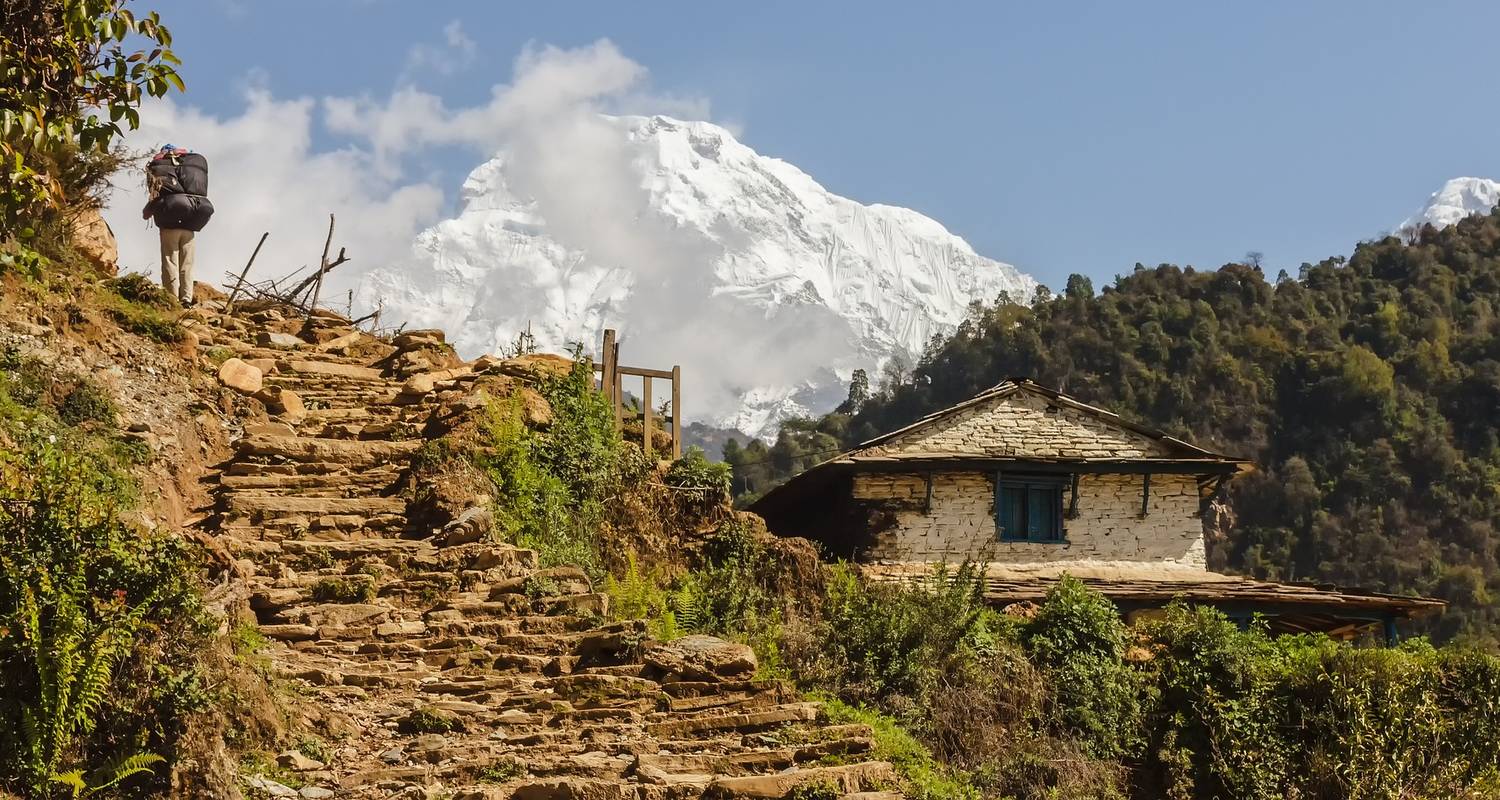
left=141, top=0, right=1500, bottom=287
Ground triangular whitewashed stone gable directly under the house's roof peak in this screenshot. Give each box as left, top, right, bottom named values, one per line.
left=867, top=392, right=1172, bottom=458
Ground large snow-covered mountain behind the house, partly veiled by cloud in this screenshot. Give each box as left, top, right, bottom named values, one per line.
left=359, top=117, right=1037, bottom=437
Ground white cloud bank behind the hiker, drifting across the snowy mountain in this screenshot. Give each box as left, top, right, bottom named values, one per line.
left=107, top=38, right=848, bottom=426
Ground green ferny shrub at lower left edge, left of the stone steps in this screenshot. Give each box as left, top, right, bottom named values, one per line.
left=0, top=434, right=212, bottom=795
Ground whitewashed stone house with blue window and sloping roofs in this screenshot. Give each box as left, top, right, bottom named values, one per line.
left=752, top=378, right=1442, bottom=635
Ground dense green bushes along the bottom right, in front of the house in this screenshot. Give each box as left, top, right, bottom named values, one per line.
left=786, top=569, right=1500, bottom=800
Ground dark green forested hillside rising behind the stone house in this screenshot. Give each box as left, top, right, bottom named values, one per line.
left=726, top=216, right=1500, bottom=642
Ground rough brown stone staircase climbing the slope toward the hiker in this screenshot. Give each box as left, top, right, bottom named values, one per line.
left=183, top=309, right=899, bottom=800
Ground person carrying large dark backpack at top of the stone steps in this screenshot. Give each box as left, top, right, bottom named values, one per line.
left=141, top=144, right=213, bottom=306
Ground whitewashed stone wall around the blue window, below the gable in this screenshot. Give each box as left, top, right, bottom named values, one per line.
left=854, top=473, right=1206, bottom=569
